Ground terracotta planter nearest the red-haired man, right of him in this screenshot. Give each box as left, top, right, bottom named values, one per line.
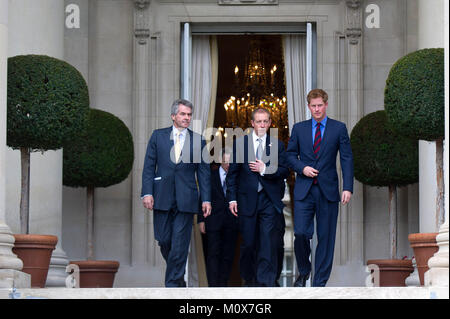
left=367, top=259, right=414, bottom=287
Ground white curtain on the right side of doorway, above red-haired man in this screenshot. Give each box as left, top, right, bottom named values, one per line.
left=283, top=34, right=307, bottom=130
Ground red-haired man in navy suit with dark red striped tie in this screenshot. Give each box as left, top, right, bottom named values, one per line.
left=286, top=89, right=353, bottom=287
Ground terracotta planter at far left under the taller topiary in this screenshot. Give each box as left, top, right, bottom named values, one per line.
left=12, top=234, right=58, bottom=288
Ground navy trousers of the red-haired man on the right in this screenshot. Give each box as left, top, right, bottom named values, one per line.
left=294, top=185, right=339, bottom=287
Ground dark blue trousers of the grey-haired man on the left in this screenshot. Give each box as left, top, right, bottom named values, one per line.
left=153, top=209, right=194, bottom=287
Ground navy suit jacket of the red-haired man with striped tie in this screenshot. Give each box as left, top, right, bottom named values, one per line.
left=286, top=118, right=353, bottom=202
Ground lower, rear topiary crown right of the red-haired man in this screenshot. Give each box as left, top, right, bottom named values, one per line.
left=350, top=111, right=419, bottom=186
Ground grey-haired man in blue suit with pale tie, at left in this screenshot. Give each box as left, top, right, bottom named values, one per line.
left=141, top=99, right=211, bottom=287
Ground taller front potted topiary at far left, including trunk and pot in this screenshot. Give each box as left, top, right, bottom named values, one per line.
left=7, top=55, right=89, bottom=287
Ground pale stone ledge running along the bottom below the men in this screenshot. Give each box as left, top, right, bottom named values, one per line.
left=0, top=287, right=449, bottom=299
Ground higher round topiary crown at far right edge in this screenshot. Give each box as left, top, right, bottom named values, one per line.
left=384, top=49, right=445, bottom=141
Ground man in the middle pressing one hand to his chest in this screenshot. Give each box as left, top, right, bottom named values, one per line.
left=227, top=108, right=289, bottom=287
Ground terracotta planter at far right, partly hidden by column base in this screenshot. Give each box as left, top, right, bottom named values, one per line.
left=408, top=233, right=439, bottom=286
